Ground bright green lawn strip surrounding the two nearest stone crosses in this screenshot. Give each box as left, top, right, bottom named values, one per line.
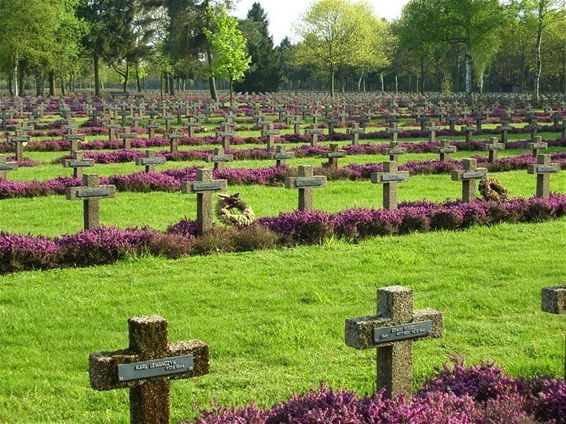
left=0, top=220, right=566, bottom=423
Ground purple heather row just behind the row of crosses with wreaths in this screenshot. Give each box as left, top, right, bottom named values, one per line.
left=0, top=151, right=566, bottom=199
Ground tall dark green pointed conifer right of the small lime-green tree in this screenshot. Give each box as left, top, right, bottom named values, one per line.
left=235, top=3, right=282, bottom=93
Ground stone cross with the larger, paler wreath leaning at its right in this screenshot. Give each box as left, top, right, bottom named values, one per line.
left=182, top=169, right=228, bottom=235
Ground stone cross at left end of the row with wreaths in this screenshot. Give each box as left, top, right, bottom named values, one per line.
left=65, top=174, right=116, bottom=230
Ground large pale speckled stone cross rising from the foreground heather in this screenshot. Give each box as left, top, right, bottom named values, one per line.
left=345, top=286, right=444, bottom=398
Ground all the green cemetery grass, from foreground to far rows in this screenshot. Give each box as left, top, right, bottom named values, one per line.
left=0, top=102, right=566, bottom=423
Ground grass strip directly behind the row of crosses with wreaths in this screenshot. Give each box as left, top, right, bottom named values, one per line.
left=0, top=171, right=566, bottom=236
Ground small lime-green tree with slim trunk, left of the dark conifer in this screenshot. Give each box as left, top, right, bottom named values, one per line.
left=203, top=6, right=251, bottom=105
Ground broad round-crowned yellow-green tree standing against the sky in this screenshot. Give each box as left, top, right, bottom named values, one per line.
left=298, top=0, right=372, bottom=96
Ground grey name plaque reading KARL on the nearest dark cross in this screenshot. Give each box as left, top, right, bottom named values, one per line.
left=118, top=355, right=194, bottom=381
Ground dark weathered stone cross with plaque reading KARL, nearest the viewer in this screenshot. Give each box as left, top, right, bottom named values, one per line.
left=89, top=316, right=210, bottom=424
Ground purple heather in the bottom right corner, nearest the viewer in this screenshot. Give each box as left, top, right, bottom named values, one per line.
left=184, top=362, right=566, bottom=424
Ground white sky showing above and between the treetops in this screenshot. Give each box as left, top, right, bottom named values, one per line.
left=236, top=0, right=408, bottom=45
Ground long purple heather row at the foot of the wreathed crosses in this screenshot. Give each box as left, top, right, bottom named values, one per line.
left=0, top=195, right=566, bottom=273
